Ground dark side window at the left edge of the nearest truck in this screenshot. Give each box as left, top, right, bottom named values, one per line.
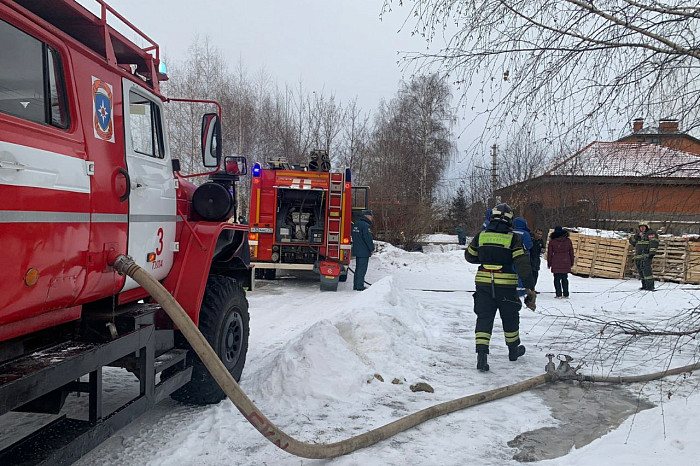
left=0, top=20, right=70, bottom=129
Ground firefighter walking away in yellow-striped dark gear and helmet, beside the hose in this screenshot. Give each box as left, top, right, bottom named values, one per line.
left=464, top=204, right=536, bottom=371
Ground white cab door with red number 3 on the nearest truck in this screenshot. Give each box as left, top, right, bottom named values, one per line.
left=123, top=79, right=177, bottom=291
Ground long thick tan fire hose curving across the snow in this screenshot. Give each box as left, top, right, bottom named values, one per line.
left=114, top=255, right=700, bottom=459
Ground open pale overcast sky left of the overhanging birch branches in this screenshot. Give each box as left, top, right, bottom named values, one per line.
left=108, top=0, right=438, bottom=122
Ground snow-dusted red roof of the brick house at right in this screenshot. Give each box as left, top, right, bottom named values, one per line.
left=545, top=141, right=700, bottom=178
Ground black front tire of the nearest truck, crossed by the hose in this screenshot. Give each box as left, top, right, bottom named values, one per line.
left=170, top=275, right=250, bottom=405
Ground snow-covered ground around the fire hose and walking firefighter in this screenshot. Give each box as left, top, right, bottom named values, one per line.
left=78, top=236, right=700, bottom=466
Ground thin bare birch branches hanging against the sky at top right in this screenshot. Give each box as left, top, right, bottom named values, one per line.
left=384, top=0, right=700, bottom=140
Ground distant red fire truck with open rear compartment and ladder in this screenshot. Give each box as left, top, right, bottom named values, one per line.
left=249, top=151, right=366, bottom=291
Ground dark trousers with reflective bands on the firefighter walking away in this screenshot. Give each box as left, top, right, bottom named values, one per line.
left=474, top=285, right=522, bottom=352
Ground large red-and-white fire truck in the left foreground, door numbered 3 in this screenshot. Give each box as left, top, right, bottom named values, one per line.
left=0, top=0, right=252, bottom=465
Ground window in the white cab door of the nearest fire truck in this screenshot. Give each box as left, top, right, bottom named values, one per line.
left=129, top=91, right=164, bottom=159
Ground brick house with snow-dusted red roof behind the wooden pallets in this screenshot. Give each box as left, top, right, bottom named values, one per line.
left=495, top=128, right=700, bottom=234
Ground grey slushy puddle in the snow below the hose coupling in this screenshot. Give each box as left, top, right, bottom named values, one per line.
left=508, top=382, right=654, bottom=462
